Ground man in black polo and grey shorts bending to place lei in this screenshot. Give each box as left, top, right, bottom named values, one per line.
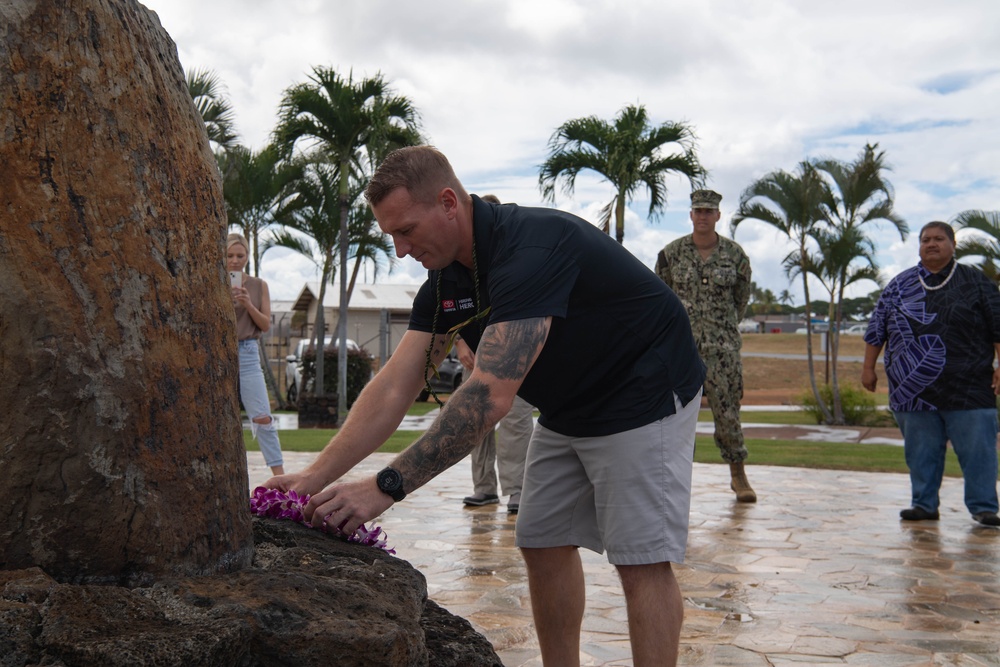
left=267, top=146, right=705, bottom=665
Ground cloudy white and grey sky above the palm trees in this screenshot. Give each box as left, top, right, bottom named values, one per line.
left=143, top=0, right=1000, bottom=299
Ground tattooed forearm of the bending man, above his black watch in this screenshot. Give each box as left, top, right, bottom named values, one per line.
left=393, top=380, right=493, bottom=493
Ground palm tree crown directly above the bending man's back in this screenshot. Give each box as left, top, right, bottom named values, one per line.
left=538, top=105, right=705, bottom=243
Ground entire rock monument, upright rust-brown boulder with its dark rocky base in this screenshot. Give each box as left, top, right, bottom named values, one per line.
left=0, top=0, right=500, bottom=667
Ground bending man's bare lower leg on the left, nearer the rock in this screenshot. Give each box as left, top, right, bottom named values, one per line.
left=521, top=547, right=584, bottom=667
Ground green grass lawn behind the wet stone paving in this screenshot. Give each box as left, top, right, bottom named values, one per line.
left=243, top=402, right=961, bottom=477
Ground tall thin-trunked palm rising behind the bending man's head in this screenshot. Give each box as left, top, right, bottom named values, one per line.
left=275, top=67, right=421, bottom=421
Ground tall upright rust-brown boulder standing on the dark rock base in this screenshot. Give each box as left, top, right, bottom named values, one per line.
left=0, top=0, right=253, bottom=584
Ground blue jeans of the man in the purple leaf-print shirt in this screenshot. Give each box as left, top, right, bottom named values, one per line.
left=893, top=408, right=997, bottom=514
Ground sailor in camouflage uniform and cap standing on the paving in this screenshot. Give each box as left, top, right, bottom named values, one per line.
left=656, top=190, right=757, bottom=503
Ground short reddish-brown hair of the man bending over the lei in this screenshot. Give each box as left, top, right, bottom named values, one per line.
left=365, top=146, right=469, bottom=205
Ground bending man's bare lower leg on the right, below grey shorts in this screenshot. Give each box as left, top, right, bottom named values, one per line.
left=620, top=563, right=684, bottom=667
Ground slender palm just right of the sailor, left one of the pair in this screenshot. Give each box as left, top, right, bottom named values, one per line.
left=730, top=162, right=833, bottom=421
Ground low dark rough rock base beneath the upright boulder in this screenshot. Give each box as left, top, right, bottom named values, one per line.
left=0, top=518, right=502, bottom=667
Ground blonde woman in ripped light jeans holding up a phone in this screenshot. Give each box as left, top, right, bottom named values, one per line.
left=226, top=234, right=285, bottom=475
